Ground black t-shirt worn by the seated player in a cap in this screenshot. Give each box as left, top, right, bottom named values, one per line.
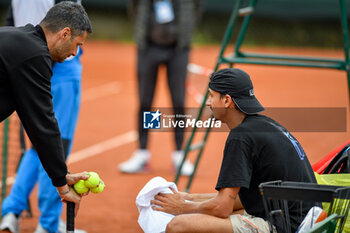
left=216, top=115, right=316, bottom=230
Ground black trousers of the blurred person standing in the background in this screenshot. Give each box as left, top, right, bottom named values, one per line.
left=137, top=44, right=189, bottom=150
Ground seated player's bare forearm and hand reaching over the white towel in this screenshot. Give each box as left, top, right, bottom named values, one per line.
left=151, top=187, right=240, bottom=218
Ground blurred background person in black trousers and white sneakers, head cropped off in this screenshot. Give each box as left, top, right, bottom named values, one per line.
left=119, top=0, right=202, bottom=176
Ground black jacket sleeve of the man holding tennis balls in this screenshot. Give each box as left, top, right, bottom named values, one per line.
left=9, top=56, right=67, bottom=187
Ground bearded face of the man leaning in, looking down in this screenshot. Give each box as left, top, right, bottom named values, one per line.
left=51, top=31, right=87, bottom=63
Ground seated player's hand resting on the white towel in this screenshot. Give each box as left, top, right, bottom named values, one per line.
left=151, top=188, right=186, bottom=215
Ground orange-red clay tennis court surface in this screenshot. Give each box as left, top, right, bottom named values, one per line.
left=10, top=41, right=350, bottom=233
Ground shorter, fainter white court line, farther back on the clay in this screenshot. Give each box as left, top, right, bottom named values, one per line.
left=81, top=82, right=121, bottom=102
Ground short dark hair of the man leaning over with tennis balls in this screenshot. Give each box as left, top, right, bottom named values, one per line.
left=40, top=1, right=92, bottom=38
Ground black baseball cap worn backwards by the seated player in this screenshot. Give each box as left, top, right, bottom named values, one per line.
left=209, top=68, right=264, bottom=115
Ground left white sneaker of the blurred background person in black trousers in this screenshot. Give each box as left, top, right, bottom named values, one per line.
left=119, top=149, right=151, bottom=173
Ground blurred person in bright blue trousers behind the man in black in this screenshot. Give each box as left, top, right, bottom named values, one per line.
left=0, top=0, right=85, bottom=233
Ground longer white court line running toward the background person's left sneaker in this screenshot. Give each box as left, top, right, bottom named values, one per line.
left=0, top=130, right=138, bottom=188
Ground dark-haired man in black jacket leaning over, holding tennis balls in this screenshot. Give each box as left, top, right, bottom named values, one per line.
left=0, top=2, right=92, bottom=217
